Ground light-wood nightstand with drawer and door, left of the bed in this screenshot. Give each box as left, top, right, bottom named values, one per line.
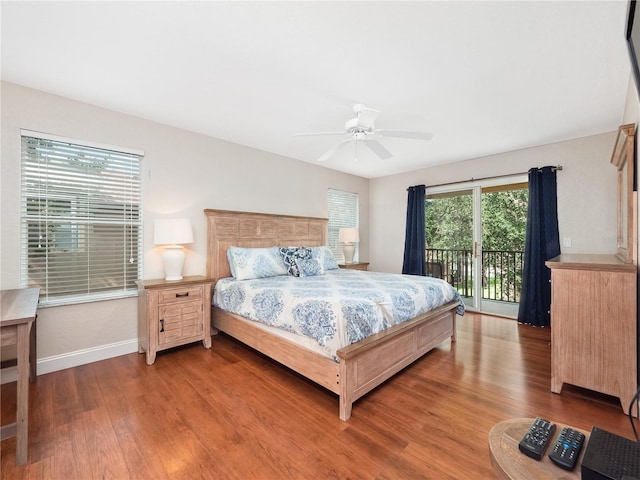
left=136, top=276, right=213, bottom=365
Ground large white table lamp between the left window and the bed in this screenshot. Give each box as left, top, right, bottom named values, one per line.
left=153, top=218, right=193, bottom=280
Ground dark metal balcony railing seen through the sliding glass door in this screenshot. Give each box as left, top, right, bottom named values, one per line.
left=426, top=248, right=524, bottom=303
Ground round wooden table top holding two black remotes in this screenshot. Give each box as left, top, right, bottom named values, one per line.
left=489, top=418, right=589, bottom=480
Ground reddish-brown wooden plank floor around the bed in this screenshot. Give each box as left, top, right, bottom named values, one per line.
left=0, top=313, right=632, bottom=480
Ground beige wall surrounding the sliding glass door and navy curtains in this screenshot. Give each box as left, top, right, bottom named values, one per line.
left=369, top=132, right=617, bottom=272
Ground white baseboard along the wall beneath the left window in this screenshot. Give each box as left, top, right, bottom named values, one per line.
left=0, top=338, right=138, bottom=384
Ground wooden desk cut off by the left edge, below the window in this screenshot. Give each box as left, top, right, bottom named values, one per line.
left=0, top=288, right=40, bottom=465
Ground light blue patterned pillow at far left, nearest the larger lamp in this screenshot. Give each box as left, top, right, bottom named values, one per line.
left=227, top=247, right=287, bottom=280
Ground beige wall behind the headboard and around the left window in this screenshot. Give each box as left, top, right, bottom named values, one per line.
left=0, top=82, right=369, bottom=372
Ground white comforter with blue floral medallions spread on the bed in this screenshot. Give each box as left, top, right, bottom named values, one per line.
left=213, top=270, right=464, bottom=358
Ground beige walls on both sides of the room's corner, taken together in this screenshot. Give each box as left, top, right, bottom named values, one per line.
left=0, top=79, right=638, bottom=373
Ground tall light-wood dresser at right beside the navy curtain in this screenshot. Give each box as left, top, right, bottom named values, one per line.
left=546, top=255, right=638, bottom=413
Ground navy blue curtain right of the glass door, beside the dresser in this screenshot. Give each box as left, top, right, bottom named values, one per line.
left=518, top=167, right=560, bottom=327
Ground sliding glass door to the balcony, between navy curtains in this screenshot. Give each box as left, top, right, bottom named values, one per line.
left=425, top=177, right=528, bottom=318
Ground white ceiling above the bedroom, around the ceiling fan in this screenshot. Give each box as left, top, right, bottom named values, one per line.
left=1, top=0, right=630, bottom=178
